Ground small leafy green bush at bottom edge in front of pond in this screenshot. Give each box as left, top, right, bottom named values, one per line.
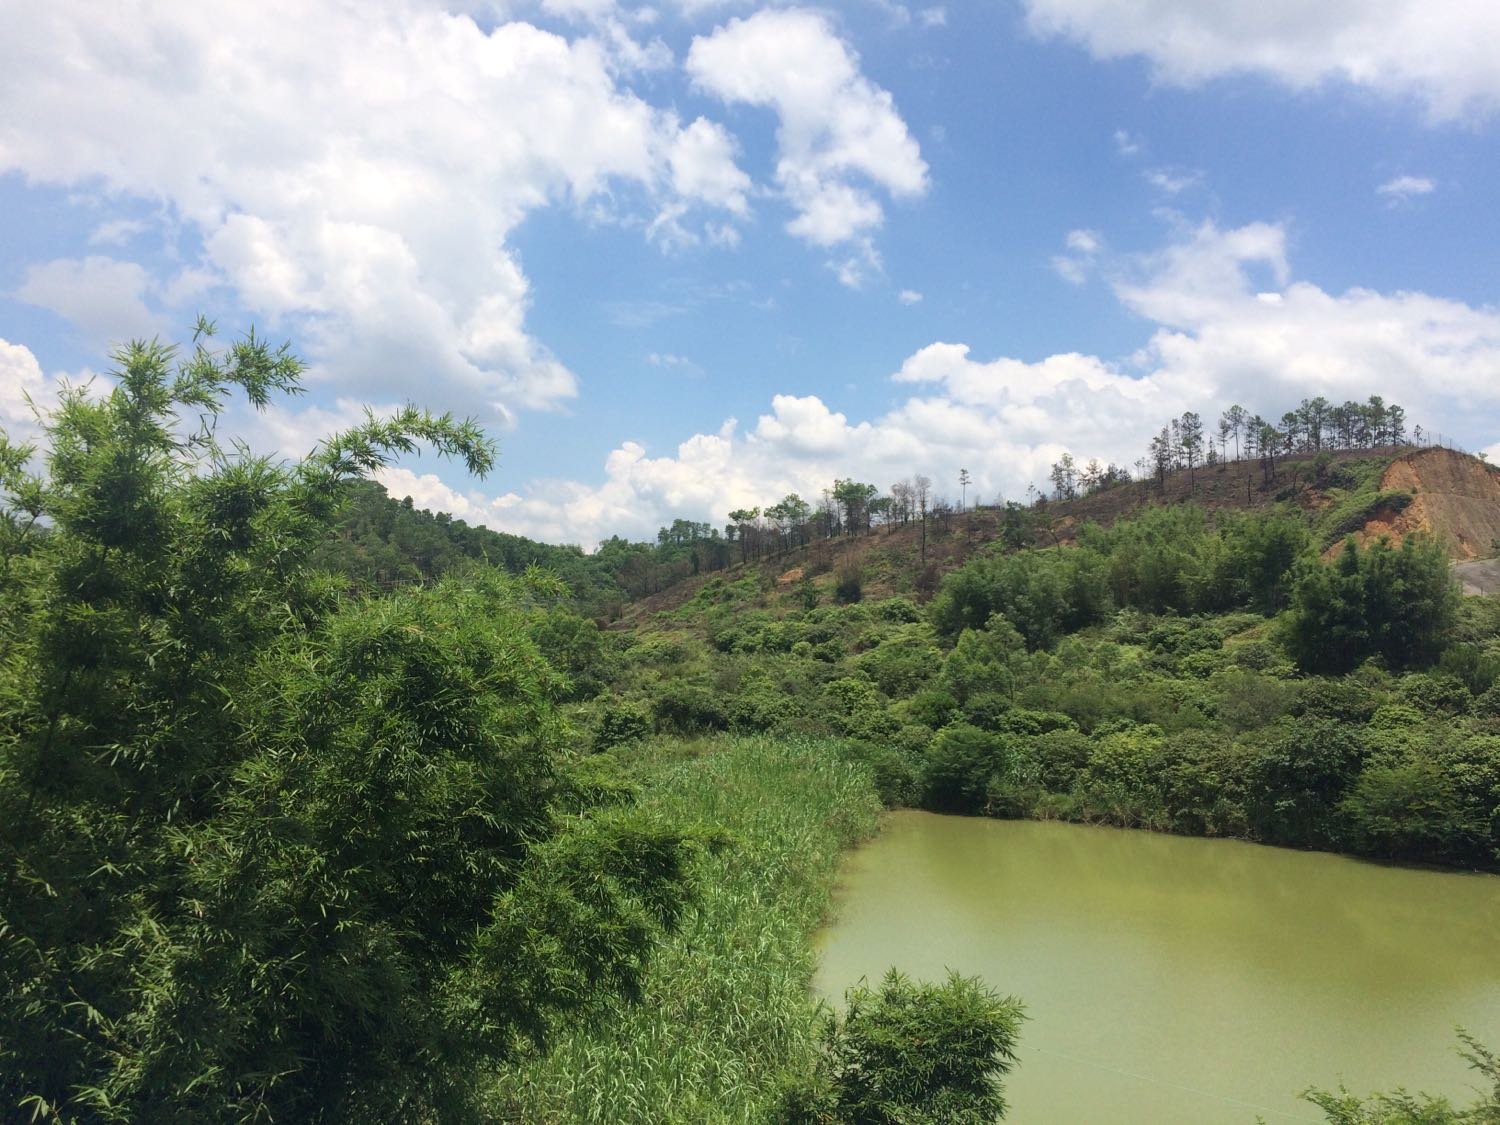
left=779, top=969, right=1025, bottom=1125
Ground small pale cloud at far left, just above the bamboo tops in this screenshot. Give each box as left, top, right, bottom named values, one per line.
left=12, top=257, right=162, bottom=347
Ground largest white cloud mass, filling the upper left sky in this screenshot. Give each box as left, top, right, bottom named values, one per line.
left=0, top=0, right=749, bottom=419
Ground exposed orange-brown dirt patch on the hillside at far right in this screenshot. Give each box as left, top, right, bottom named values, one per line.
left=1355, top=449, right=1500, bottom=560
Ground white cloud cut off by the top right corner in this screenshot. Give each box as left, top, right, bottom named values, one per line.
left=1025, top=0, right=1500, bottom=120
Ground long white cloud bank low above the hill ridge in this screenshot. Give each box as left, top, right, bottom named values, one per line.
left=447, top=224, right=1500, bottom=545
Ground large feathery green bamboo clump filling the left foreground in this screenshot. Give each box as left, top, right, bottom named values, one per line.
left=0, top=334, right=698, bottom=1121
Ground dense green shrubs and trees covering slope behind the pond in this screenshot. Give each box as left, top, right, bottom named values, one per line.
left=581, top=506, right=1500, bottom=869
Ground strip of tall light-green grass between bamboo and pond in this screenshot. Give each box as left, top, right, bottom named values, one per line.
left=491, top=738, right=881, bottom=1125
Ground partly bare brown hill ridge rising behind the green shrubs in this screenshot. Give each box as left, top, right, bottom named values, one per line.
left=325, top=446, right=1500, bottom=623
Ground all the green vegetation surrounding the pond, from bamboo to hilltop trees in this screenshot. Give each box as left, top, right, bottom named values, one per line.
left=0, top=324, right=1500, bottom=1124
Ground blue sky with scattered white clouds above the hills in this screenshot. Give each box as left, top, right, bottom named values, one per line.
left=0, top=0, right=1500, bottom=549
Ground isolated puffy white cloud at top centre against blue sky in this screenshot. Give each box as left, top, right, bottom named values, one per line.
left=687, top=9, right=927, bottom=255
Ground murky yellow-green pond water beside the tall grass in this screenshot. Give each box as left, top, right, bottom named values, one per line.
left=816, top=812, right=1500, bottom=1125
